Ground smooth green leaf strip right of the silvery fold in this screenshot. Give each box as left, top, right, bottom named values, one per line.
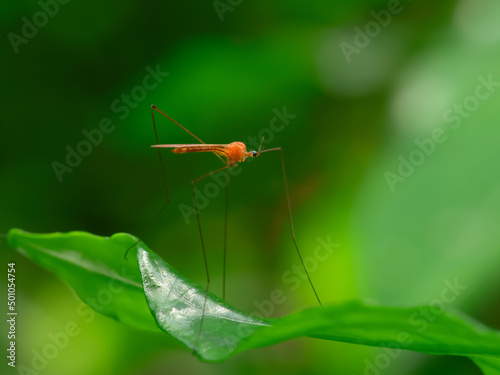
left=238, top=301, right=500, bottom=359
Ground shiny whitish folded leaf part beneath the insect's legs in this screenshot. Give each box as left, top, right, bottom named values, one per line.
left=137, top=248, right=270, bottom=361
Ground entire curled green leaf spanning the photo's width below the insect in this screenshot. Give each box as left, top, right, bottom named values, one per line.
left=8, top=230, right=500, bottom=375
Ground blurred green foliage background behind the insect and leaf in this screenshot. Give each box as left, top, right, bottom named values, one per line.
left=0, top=0, right=500, bottom=375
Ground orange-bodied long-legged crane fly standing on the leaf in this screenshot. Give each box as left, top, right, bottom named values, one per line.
left=127, top=105, right=322, bottom=349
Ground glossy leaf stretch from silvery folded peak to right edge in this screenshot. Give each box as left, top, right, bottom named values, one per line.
left=138, top=238, right=500, bottom=373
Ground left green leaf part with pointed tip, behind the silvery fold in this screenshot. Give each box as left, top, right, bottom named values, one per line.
left=7, top=229, right=159, bottom=332
